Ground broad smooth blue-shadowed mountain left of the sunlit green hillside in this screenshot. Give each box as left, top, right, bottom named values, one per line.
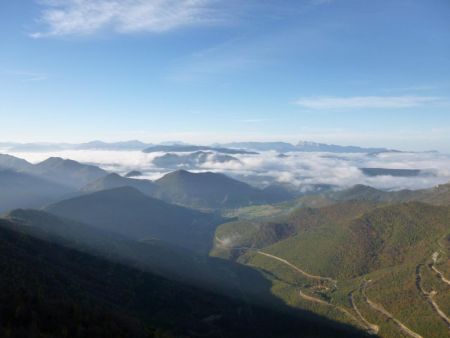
left=45, top=187, right=221, bottom=252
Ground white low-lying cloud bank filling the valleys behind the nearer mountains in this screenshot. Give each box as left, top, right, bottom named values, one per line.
left=0, top=150, right=450, bottom=190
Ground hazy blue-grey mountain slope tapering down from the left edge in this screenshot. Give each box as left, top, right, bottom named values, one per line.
left=0, top=169, right=72, bottom=212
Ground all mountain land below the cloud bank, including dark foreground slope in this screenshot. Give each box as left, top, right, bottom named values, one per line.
left=0, top=149, right=450, bottom=338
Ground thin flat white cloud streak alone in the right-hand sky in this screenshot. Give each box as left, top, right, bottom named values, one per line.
left=295, top=95, right=442, bottom=109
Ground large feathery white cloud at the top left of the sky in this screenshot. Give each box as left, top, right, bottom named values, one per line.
left=31, top=0, right=226, bottom=38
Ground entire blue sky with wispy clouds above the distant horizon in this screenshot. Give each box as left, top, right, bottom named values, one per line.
left=0, top=0, right=450, bottom=151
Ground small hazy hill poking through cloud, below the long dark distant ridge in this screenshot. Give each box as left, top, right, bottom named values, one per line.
left=152, top=151, right=239, bottom=169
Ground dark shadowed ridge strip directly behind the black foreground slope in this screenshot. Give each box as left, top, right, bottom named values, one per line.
left=3, top=209, right=256, bottom=295
